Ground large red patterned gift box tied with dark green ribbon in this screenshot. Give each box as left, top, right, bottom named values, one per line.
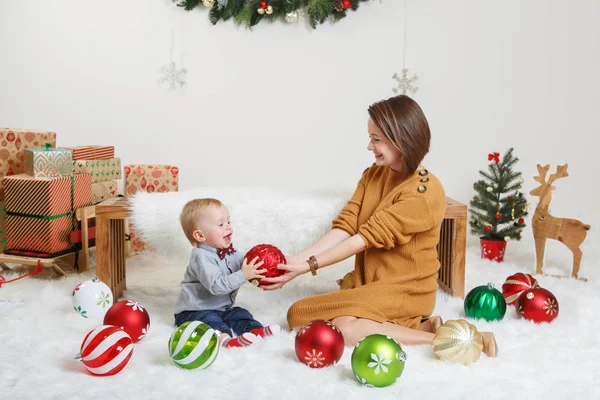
left=4, top=174, right=92, bottom=253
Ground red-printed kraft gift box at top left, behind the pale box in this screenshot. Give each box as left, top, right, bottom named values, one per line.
left=0, top=128, right=56, bottom=177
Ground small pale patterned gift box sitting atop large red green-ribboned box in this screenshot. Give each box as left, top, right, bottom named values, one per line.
left=24, top=144, right=73, bottom=178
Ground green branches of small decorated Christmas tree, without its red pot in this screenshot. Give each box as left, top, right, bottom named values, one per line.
left=469, top=148, right=527, bottom=241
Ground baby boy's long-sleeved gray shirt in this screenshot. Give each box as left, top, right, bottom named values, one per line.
left=175, top=244, right=246, bottom=314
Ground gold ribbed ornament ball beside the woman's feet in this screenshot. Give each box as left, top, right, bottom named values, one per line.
left=433, top=319, right=483, bottom=365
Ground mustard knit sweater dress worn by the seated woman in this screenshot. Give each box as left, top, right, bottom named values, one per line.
left=287, top=165, right=446, bottom=329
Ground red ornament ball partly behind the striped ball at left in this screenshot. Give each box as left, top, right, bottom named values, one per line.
left=104, top=300, right=150, bottom=343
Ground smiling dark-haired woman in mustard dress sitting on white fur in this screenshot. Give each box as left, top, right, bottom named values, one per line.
left=263, top=95, right=496, bottom=356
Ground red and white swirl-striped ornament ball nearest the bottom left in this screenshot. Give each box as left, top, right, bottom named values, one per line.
left=75, top=325, right=133, bottom=376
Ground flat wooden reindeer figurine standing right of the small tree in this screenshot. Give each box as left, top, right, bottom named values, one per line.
left=529, top=164, right=590, bottom=280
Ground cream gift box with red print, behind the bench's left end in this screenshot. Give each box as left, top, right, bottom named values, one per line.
left=125, top=164, right=179, bottom=253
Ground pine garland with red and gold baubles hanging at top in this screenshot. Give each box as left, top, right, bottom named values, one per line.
left=173, top=0, right=369, bottom=29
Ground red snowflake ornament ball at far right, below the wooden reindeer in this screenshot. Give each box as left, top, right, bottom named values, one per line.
left=517, top=287, right=558, bottom=324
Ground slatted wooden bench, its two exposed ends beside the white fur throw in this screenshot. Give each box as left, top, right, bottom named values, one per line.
left=95, top=198, right=467, bottom=299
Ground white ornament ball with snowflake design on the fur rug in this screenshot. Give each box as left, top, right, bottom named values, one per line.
left=72, top=278, right=113, bottom=319
